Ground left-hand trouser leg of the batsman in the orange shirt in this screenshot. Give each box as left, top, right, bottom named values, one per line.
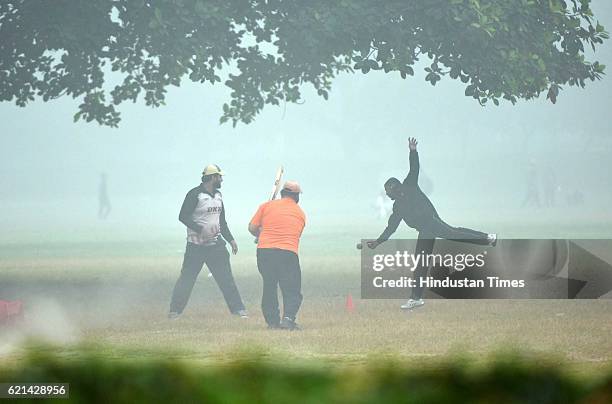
left=257, top=248, right=280, bottom=328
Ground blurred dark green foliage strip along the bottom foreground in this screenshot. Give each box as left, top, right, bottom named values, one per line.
left=0, top=348, right=612, bottom=403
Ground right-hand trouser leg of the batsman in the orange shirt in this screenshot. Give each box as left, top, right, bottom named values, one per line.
left=279, top=251, right=302, bottom=321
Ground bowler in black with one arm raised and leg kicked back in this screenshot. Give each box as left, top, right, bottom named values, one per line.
left=357, top=138, right=497, bottom=309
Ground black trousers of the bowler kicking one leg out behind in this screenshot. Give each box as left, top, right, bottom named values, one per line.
left=410, top=217, right=489, bottom=300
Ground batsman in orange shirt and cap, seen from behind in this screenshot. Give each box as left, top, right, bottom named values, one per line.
left=249, top=181, right=306, bottom=330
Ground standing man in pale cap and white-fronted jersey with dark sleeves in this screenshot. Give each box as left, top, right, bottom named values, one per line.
left=168, top=164, right=248, bottom=319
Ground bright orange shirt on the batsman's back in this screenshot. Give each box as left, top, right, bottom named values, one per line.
left=251, top=198, right=306, bottom=254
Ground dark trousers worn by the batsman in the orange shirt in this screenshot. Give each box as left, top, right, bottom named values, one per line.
left=257, top=248, right=302, bottom=327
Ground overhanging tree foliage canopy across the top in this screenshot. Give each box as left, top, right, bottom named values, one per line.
left=0, top=0, right=608, bottom=126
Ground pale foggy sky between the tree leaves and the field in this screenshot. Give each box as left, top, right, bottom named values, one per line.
left=0, top=1, right=612, bottom=241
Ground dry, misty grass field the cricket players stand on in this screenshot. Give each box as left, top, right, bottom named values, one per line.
left=0, top=224, right=612, bottom=374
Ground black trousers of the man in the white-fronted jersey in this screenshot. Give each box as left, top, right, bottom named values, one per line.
left=170, top=243, right=244, bottom=314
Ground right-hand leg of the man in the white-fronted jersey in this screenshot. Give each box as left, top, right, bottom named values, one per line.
left=204, top=241, right=244, bottom=314
